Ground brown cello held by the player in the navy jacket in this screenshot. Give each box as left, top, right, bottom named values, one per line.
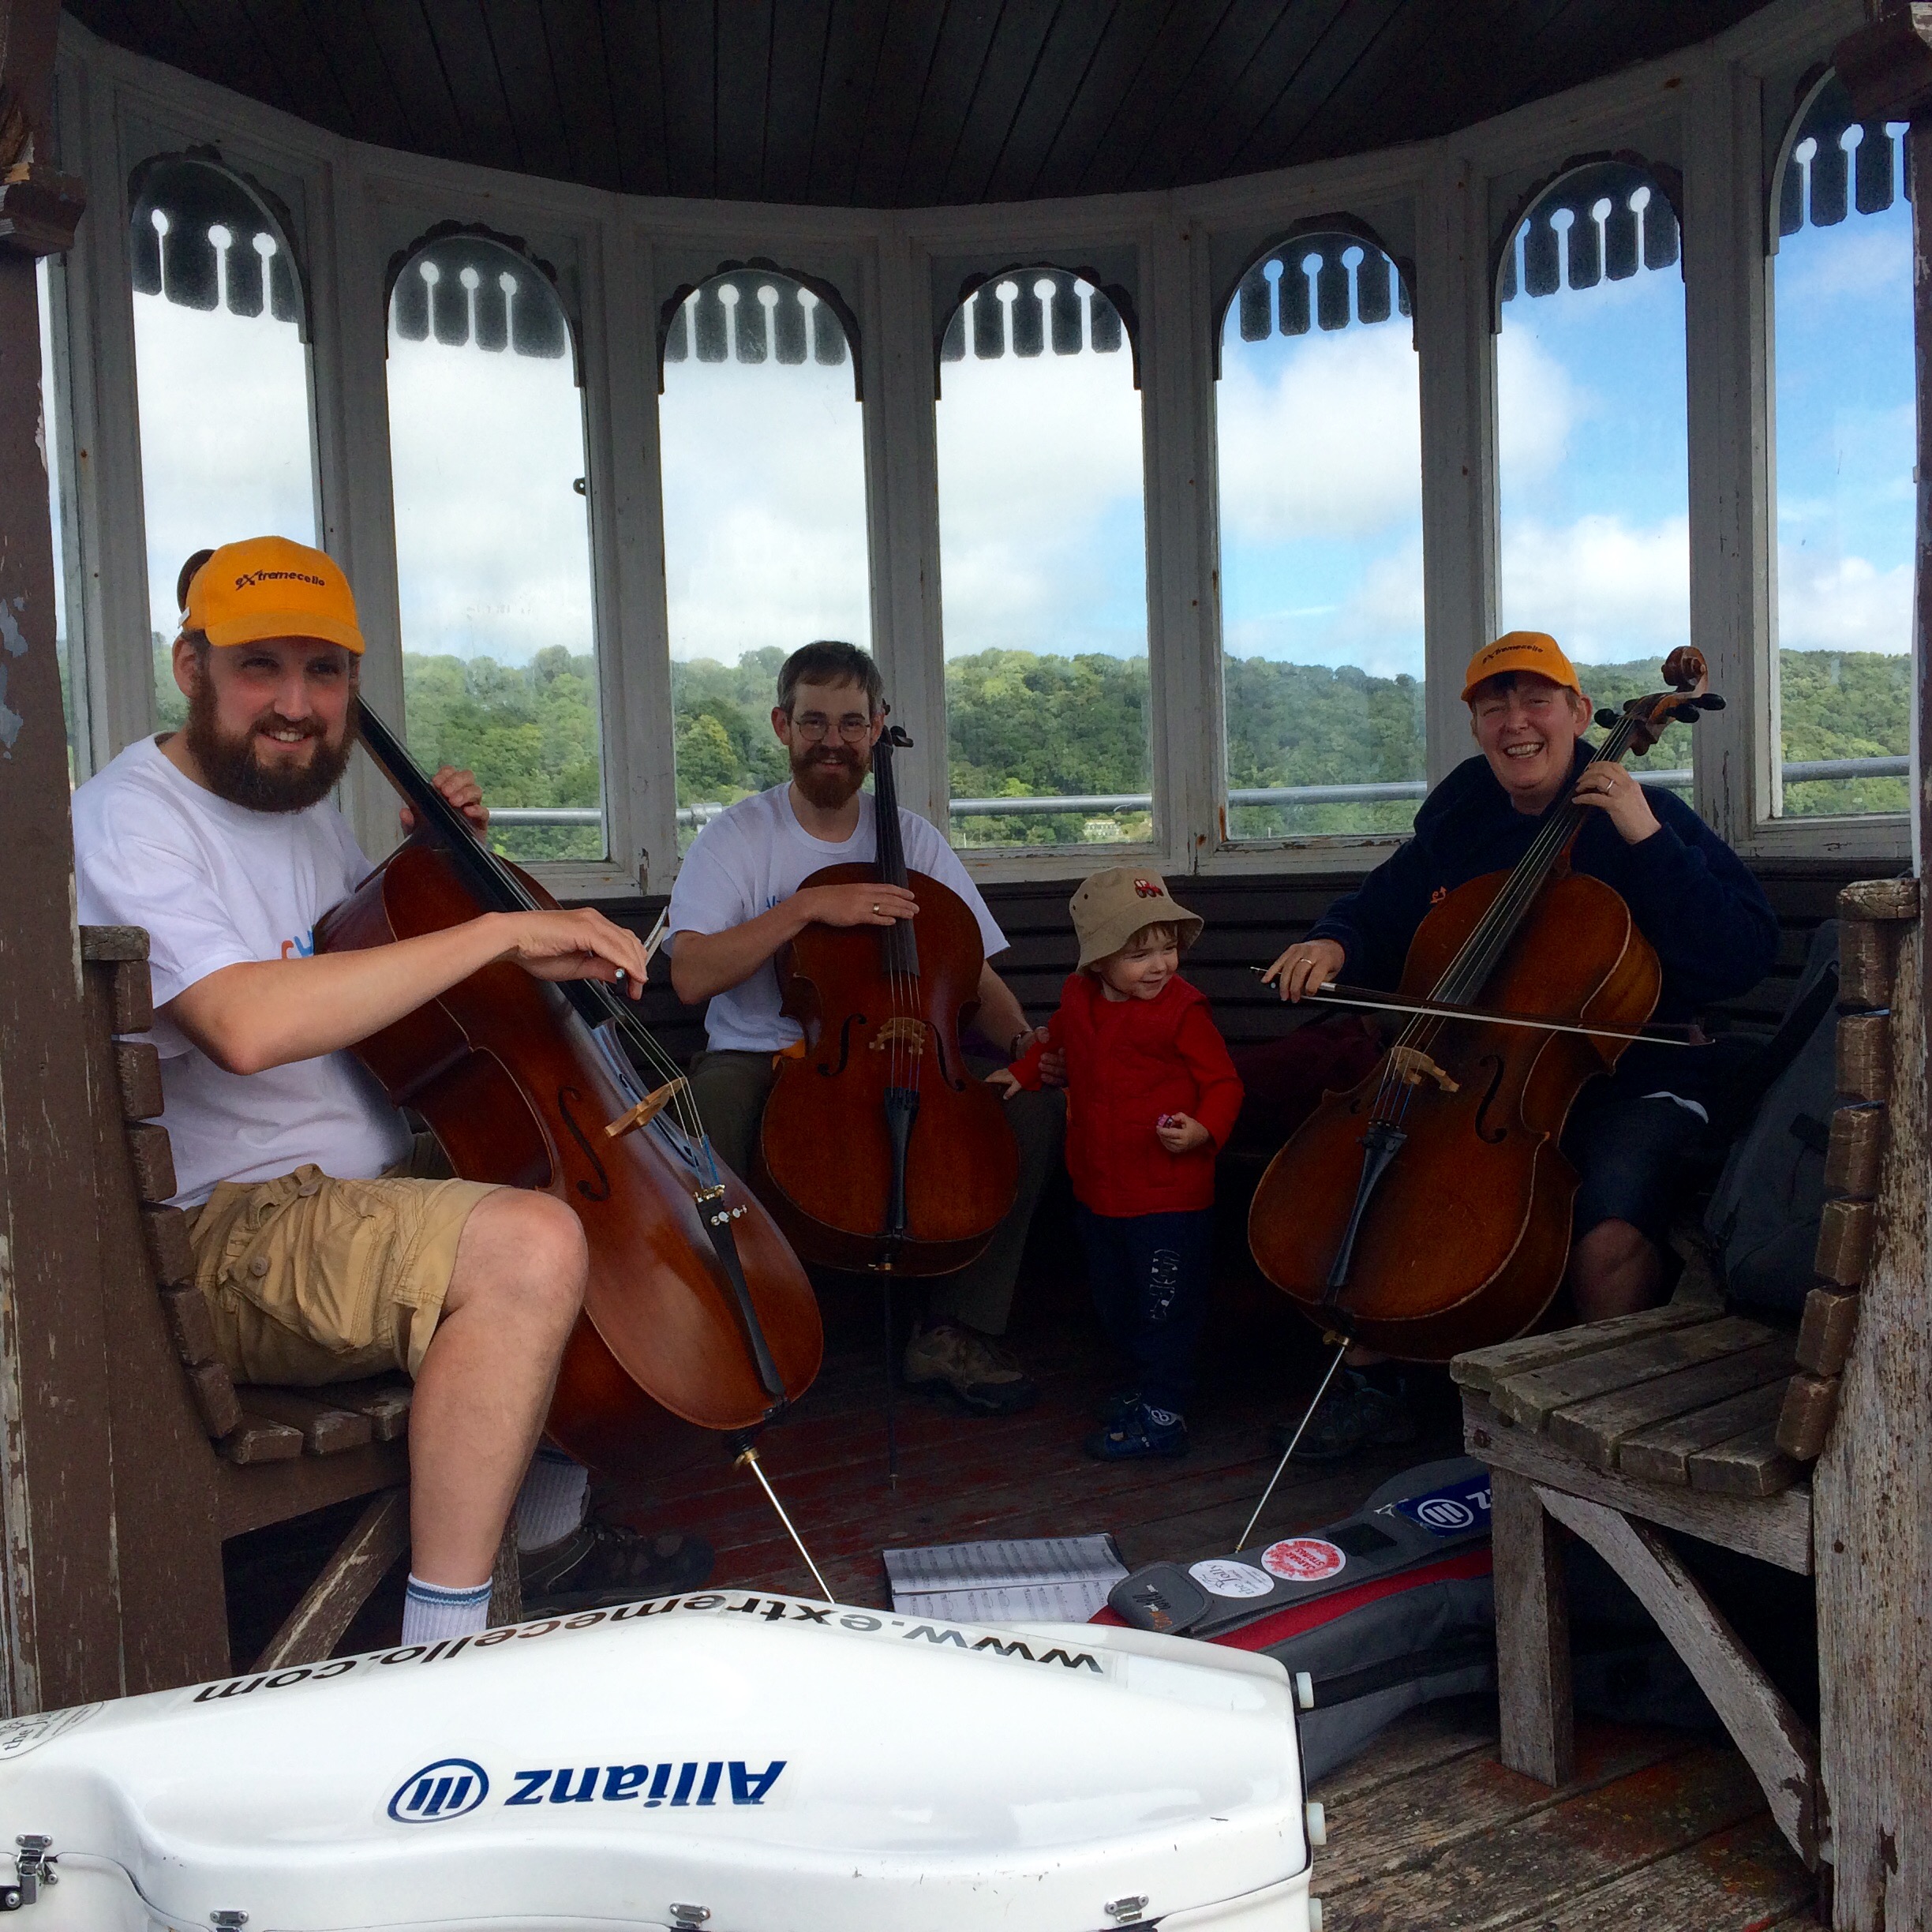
left=1248, top=647, right=1724, bottom=1360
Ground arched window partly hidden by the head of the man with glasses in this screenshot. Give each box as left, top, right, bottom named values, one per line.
left=657, top=267, right=871, bottom=852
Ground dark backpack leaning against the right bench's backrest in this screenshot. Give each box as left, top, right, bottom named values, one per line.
left=1704, top=919, right=1837, bottom=1314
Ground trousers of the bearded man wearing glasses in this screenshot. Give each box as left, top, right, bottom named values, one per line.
left=690, top=1051, right=1066, bottom=1335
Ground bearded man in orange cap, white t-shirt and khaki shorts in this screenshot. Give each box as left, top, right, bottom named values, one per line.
left=73, top=537, right=711, bottom=1644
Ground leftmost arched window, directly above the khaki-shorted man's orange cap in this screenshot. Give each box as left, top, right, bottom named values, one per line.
left=128, top=155, right=316, bottom=728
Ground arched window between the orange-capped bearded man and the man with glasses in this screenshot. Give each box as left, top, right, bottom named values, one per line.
left=388, top=230, right=608, bottom=859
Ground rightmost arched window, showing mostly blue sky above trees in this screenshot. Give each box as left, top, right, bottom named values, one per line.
left=1772, top=77, right=1915, bottom=818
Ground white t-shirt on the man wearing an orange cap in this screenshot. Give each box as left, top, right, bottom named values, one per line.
left=73, top=738, right=410, bottom=1208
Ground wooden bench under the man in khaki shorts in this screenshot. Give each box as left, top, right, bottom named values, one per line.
left=81, top=926, right=520, bottom=1690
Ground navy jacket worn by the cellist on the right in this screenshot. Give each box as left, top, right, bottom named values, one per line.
left=1308, top=742, right=1777, bottom=1101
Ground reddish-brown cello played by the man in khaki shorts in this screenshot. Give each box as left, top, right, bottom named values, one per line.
left=315, top=706, right=823, bottom=1476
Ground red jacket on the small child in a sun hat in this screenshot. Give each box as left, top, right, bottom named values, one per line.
left=1013, top=972, right=1241, bottom=1215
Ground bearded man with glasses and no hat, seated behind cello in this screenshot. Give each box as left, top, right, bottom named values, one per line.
left=667, top=642, right=1066, bottom=1414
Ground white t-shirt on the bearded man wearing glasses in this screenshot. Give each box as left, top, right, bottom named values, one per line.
left=670, top=782, right=1006, bottom=1053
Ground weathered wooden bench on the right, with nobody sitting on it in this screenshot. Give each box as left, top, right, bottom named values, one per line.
left=1451, top=879, right=1919, bottom=1868
